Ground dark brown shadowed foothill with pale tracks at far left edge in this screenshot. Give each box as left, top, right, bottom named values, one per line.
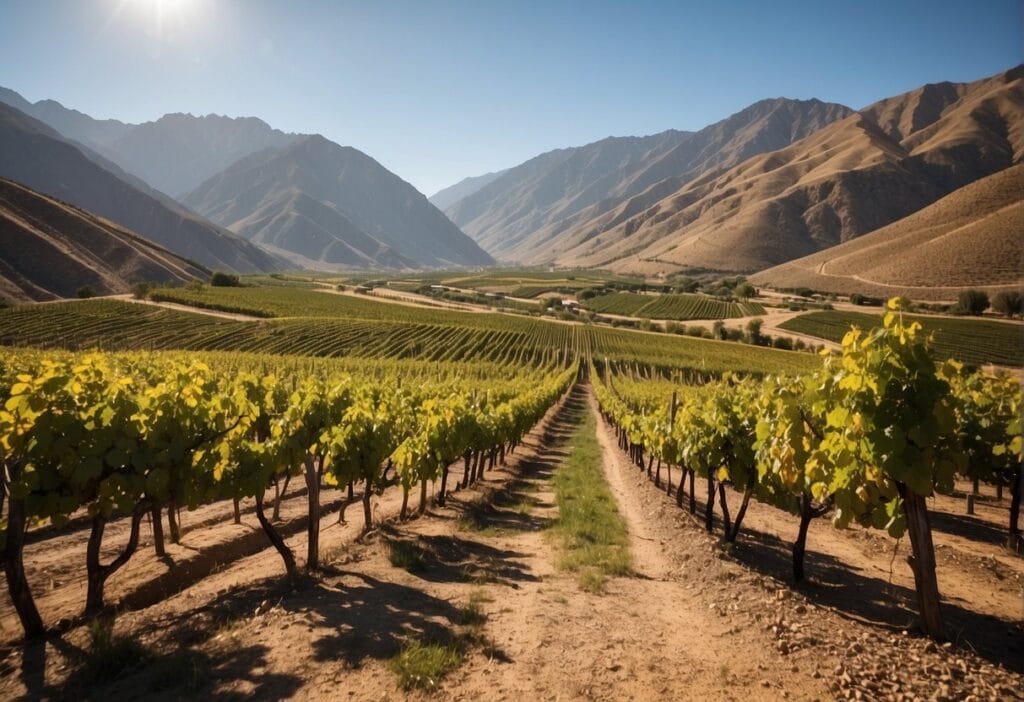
left=0, top=178, right=210, bottom=301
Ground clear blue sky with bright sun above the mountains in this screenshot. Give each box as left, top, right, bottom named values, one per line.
left=0, top=0, right=1024, bottom=194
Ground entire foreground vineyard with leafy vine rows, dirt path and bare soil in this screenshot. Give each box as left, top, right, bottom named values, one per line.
left=0, top=284, right=1024, bottom=699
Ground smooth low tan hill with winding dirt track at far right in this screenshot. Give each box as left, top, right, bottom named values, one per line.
left=751, top=164, right=1024, bottom=300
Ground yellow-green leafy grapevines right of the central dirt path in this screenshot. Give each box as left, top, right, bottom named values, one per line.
left=592, top=305, right=1024, bottom=638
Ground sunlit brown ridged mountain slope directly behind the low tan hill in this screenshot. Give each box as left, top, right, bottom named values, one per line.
left=549, top=67, right=1024, bottom=274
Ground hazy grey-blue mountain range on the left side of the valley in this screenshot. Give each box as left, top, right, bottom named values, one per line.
left=0, top=88, right=493, bottom=272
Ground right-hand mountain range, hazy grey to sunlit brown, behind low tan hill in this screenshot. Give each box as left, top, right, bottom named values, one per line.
left=446, top=67, right=1024, bottom=284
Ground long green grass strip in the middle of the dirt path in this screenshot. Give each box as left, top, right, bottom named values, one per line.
left=551, top=411, right=630, bottom=593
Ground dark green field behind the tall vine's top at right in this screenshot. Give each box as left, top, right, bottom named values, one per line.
left=779, top=310, right=1024, bottom=365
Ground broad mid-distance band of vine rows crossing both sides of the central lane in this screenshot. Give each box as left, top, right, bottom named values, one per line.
left=0, top=289, right=813, bottom=375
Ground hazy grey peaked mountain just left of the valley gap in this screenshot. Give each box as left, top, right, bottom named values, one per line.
left=182, top=135, right=493, bottom=268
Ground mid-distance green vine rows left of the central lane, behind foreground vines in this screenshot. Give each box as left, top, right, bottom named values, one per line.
left=0, top=296, right=573, bottom=362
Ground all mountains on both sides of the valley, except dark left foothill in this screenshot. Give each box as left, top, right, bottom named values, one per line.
left=0, top=62, right=1024, bottom=298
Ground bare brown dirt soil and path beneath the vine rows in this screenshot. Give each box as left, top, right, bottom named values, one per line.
left=0, top=385, right=1024, bottom=701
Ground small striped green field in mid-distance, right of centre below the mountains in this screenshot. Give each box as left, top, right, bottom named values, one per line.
left=585, top=293, right=765, bottom=320
